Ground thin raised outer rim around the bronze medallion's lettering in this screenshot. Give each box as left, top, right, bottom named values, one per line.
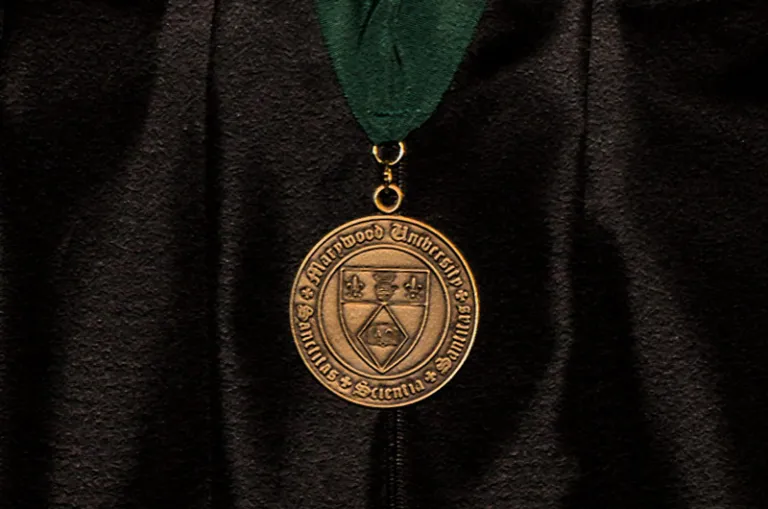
left=289, top=214, right=480, bottom=409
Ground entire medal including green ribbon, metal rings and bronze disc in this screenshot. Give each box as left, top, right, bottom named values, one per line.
left=289, top=0, right=483, bottom=408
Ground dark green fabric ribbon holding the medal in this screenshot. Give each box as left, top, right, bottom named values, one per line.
left=316, top=0, right=485, bottom=144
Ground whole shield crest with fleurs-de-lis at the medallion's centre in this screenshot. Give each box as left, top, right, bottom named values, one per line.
left=339, top=267, right=429, bottom=374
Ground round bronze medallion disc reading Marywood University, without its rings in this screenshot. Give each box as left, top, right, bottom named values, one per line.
left=290, top=216, right=478, bottom=408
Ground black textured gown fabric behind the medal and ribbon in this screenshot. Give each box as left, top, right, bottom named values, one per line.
left=0, top=0, right=768, bottom=509
